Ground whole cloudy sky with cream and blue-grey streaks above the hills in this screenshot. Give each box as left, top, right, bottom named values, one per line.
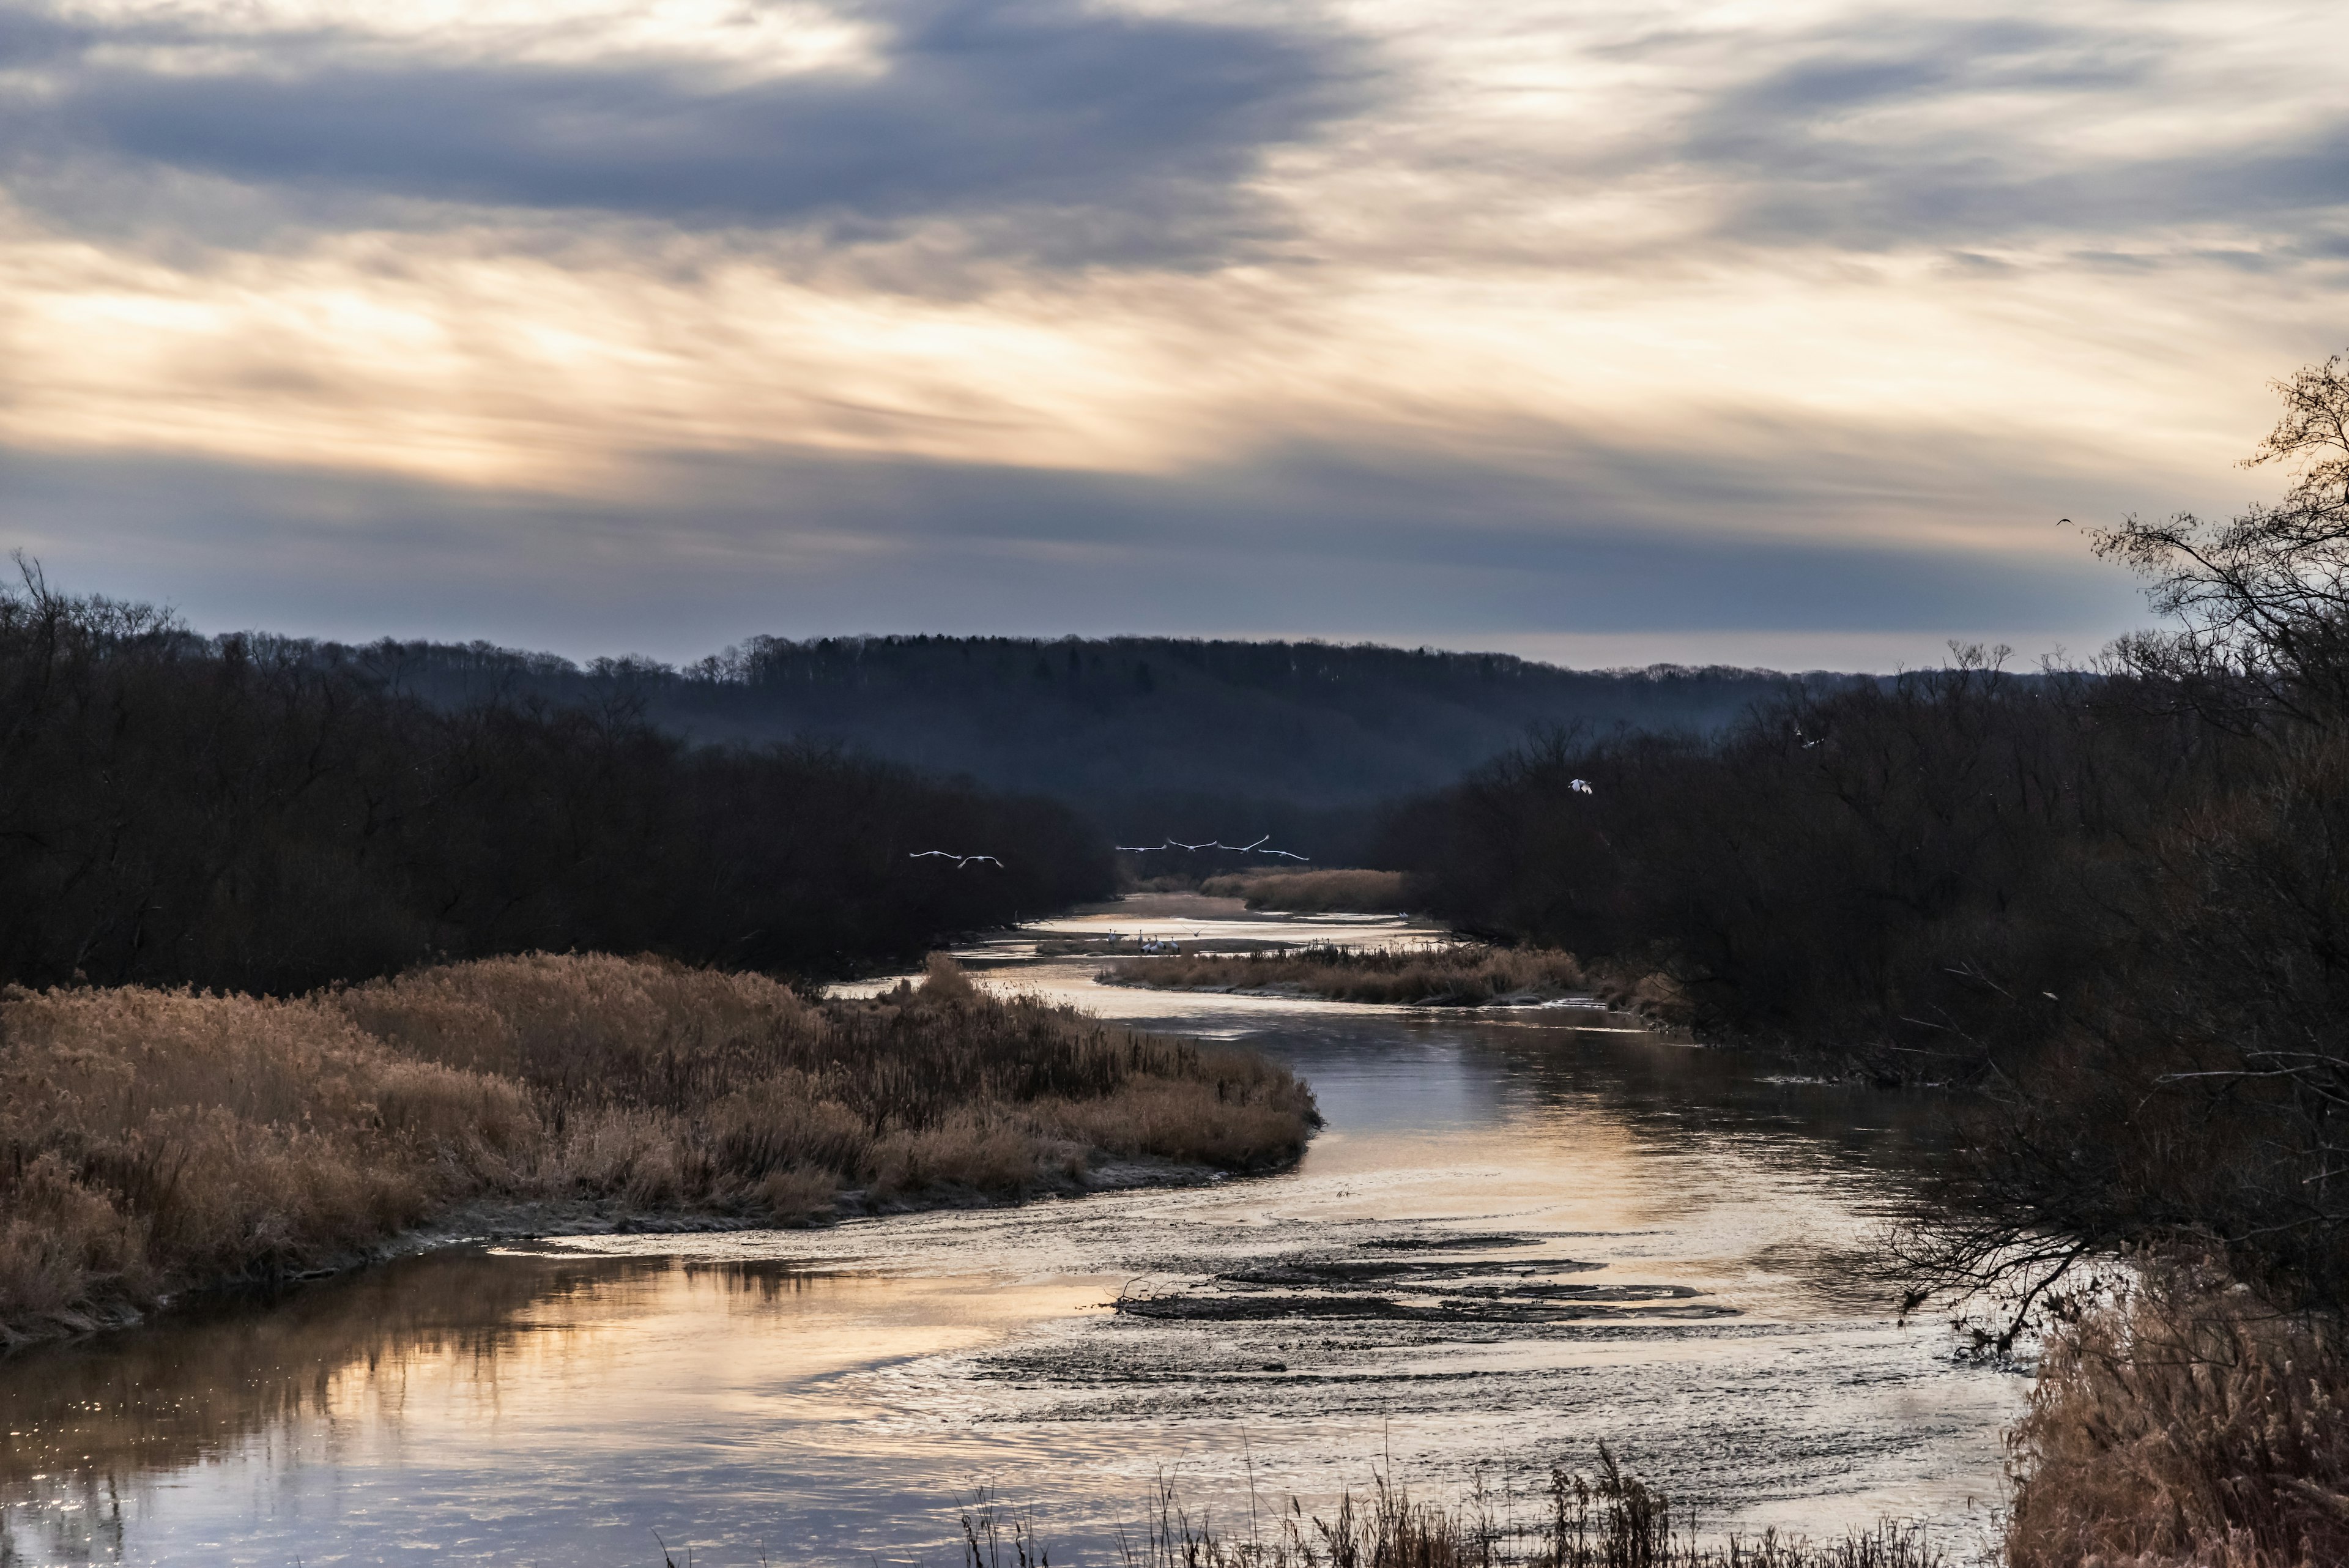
left=0, top=0, right=2349, bottom=667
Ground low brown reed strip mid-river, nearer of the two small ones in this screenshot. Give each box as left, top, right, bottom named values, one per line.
left=1099, top=943, right=1588, bottom=1006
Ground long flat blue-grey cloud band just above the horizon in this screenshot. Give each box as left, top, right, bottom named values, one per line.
left=0, top=425, right=2137, bottom=658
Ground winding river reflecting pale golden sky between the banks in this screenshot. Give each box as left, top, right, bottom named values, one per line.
left=0, top=901, right=2022, bottom=1568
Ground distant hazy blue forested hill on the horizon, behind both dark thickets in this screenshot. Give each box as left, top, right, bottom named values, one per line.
left=319, top=637, right=1850, bottom=856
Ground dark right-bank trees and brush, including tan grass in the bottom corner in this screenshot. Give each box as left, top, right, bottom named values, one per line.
left=1390, top=360, right=2349, bottom=1568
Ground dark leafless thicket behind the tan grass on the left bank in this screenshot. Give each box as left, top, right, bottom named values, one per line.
left=0, top=569, right=1113, bottom=994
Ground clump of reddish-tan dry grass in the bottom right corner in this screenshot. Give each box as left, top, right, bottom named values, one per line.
left=2006, top=1262, right=2349, bottom=1568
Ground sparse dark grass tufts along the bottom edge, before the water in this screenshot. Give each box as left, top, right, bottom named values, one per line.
left=961, top=1443, right=1950, bottom=1568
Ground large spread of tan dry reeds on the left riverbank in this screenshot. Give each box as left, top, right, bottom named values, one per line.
left=0, top=954, right=1313, bottom=1345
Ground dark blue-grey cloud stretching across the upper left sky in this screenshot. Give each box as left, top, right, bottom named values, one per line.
left=0, top=0, right=1372, bottom=266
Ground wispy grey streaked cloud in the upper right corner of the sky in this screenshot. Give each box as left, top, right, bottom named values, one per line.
left=1675, top=17, right=2349, bottom=249
